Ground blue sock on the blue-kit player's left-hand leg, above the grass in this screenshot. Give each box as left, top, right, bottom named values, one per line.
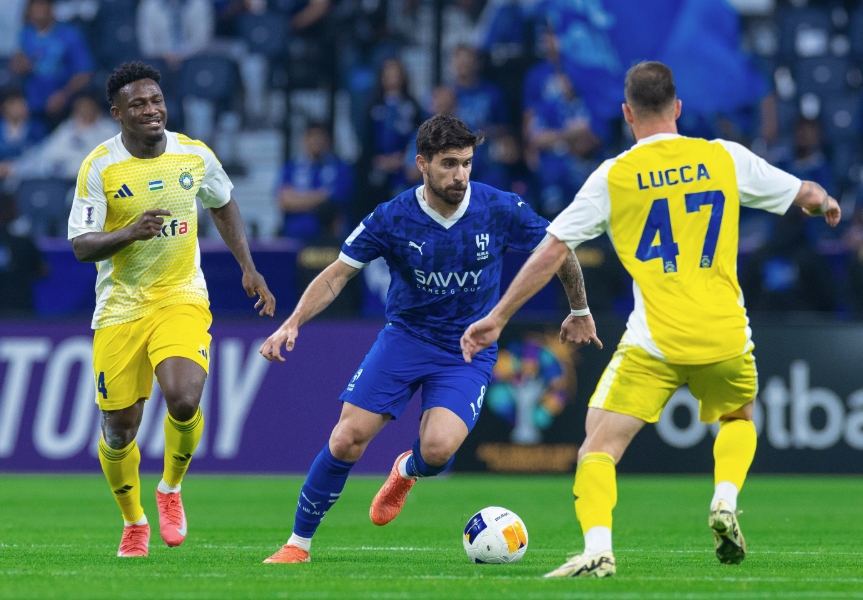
left=294, top=442, right=356, bottom=538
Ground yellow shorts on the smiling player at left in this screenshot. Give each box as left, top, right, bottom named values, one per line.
left=93, top=304, right=213, bottom=410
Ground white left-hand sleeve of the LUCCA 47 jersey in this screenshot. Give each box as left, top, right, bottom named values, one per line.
left=548, top=161, right=614, bottom=250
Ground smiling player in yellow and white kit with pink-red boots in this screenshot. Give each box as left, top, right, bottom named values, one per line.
left=69, top=63, right=275, bottom=556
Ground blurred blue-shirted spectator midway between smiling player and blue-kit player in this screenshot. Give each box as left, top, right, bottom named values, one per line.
left=278, top=125, right=353, bottom=240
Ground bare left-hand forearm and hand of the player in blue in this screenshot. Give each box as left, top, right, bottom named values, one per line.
left=258, top=259, right=360, bottom=362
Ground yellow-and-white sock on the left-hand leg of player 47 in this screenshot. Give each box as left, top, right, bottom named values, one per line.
left=572, top=452, right=617, bottom=554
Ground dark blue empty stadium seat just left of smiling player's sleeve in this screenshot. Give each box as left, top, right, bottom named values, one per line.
left=15, top=179, right=75, bottom=237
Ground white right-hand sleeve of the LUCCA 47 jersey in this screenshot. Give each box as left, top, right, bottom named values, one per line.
left=717, top=140, right=803, bottom=215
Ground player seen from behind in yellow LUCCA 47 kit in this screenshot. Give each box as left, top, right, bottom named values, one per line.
left=462, top=62, right=841, bottom=577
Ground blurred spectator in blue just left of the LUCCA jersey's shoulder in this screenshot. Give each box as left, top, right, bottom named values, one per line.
left=525, top=72, right=600, bottom=218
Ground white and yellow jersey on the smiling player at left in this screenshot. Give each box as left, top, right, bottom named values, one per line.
left=69, top=131, right=234, bottom=329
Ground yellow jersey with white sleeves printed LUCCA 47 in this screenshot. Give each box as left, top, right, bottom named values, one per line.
left=548, top=134, right=801, bottom=365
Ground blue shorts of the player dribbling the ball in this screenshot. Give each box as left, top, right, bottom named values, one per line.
left=339, top=324, right=494, bottom=431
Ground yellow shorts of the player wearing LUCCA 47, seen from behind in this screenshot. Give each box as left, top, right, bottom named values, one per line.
left=588, top=344, right=758, bottom=423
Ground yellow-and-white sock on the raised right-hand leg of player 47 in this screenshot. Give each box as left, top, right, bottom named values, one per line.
left=711, top=419, right=758, bottom=510
